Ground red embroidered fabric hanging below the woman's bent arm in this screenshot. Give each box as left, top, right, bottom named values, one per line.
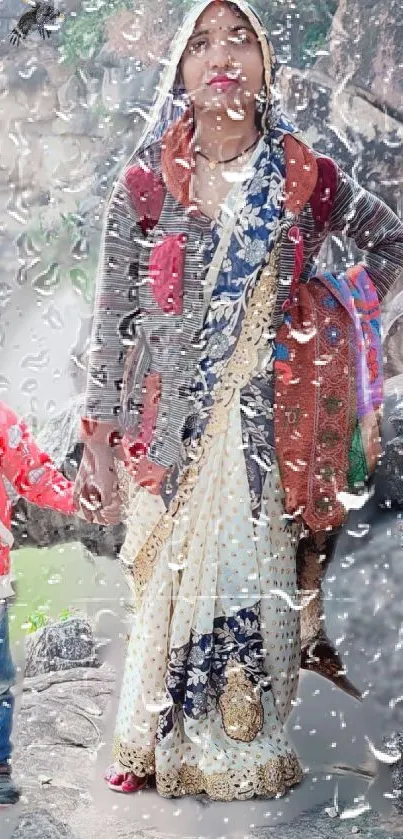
left=274, top=282, right=357, bottom=531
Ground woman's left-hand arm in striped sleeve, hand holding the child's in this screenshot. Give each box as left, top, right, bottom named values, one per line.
left=74, top=167, right=141, bottom=524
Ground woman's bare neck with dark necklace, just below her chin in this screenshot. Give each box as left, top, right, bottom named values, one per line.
left=195, top=110, right=259, bottom=160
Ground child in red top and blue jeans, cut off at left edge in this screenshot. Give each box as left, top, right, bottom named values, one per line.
left=0, top=402, right=75, bottom=808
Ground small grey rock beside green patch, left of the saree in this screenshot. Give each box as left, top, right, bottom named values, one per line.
left=25, top=618, right=99, bottom=676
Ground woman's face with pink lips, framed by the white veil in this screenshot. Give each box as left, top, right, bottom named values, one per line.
left=181, top=0, right=264, bottom=113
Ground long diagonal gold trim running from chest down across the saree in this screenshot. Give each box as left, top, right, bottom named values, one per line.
left=133, top=243, right=280, bottom=602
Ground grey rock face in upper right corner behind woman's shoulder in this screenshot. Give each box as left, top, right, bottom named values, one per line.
left=280, top=0, right=403, bottom=214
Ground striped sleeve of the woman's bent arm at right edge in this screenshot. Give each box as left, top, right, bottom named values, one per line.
left=329, top=169, right=403, bottom=300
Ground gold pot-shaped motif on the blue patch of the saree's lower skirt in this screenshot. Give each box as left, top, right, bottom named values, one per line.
left=218, top=662, right=264, bottom=743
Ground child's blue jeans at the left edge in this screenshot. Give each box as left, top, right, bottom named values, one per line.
left=0, top=601, right=15, bottom=765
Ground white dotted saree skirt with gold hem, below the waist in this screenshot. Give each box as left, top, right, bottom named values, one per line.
left=116, top=396, right=301, bottom=800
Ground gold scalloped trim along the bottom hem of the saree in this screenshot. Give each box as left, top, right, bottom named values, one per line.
left=156, top=754, right=303, bottom=801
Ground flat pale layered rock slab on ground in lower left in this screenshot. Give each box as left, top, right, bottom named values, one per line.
left=13, top=664, right=115, bottom=824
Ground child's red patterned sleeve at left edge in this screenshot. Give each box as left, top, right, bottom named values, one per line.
left=0, top=402, right=76, bottom=515
